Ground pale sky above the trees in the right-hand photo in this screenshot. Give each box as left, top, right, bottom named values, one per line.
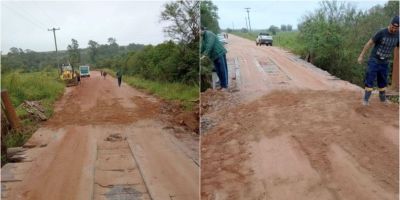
left=213, top=0, right=387, bottom=29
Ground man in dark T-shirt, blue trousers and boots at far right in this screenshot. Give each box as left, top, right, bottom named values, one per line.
left=358, top=16, right=399, bottom=105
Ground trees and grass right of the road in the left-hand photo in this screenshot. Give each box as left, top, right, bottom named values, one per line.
left=97, top=1, right=200, bottom=104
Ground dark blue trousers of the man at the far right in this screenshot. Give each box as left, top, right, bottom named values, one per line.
left=364, top=59, right=388, bottom=89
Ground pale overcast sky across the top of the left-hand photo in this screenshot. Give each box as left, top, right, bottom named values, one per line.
left=1, top=0, right=168, bottom=54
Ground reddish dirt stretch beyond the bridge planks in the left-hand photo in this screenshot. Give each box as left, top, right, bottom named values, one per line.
left=46, top=74, right=159, bottom=127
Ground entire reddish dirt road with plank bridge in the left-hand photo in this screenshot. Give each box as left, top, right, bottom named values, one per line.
left=2, top=72, right=199, bottom=200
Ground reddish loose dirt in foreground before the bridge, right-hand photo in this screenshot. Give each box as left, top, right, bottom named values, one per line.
left=201, top=91, right=399, bottom=199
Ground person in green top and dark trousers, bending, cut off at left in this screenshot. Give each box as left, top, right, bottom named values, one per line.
left=201, top=27, right=228, bottom=91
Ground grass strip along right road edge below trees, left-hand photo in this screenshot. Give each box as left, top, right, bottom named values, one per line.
left=103, top=69, right=199, bottom=110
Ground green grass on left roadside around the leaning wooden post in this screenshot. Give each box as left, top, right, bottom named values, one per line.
left=1, top=70, right=65, bottom=147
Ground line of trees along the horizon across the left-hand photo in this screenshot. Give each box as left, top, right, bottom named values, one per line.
left=1, top=0, right=200, bottom=85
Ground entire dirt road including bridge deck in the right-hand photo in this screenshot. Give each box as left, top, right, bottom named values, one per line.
left=201, top=35, right=399, bottom=200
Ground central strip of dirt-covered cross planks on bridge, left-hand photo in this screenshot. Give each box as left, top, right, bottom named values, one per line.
left=93, top=133, right=151, bottom=200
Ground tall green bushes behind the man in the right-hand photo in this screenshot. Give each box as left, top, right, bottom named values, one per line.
left=297, top=1, right=399, bottom=86
